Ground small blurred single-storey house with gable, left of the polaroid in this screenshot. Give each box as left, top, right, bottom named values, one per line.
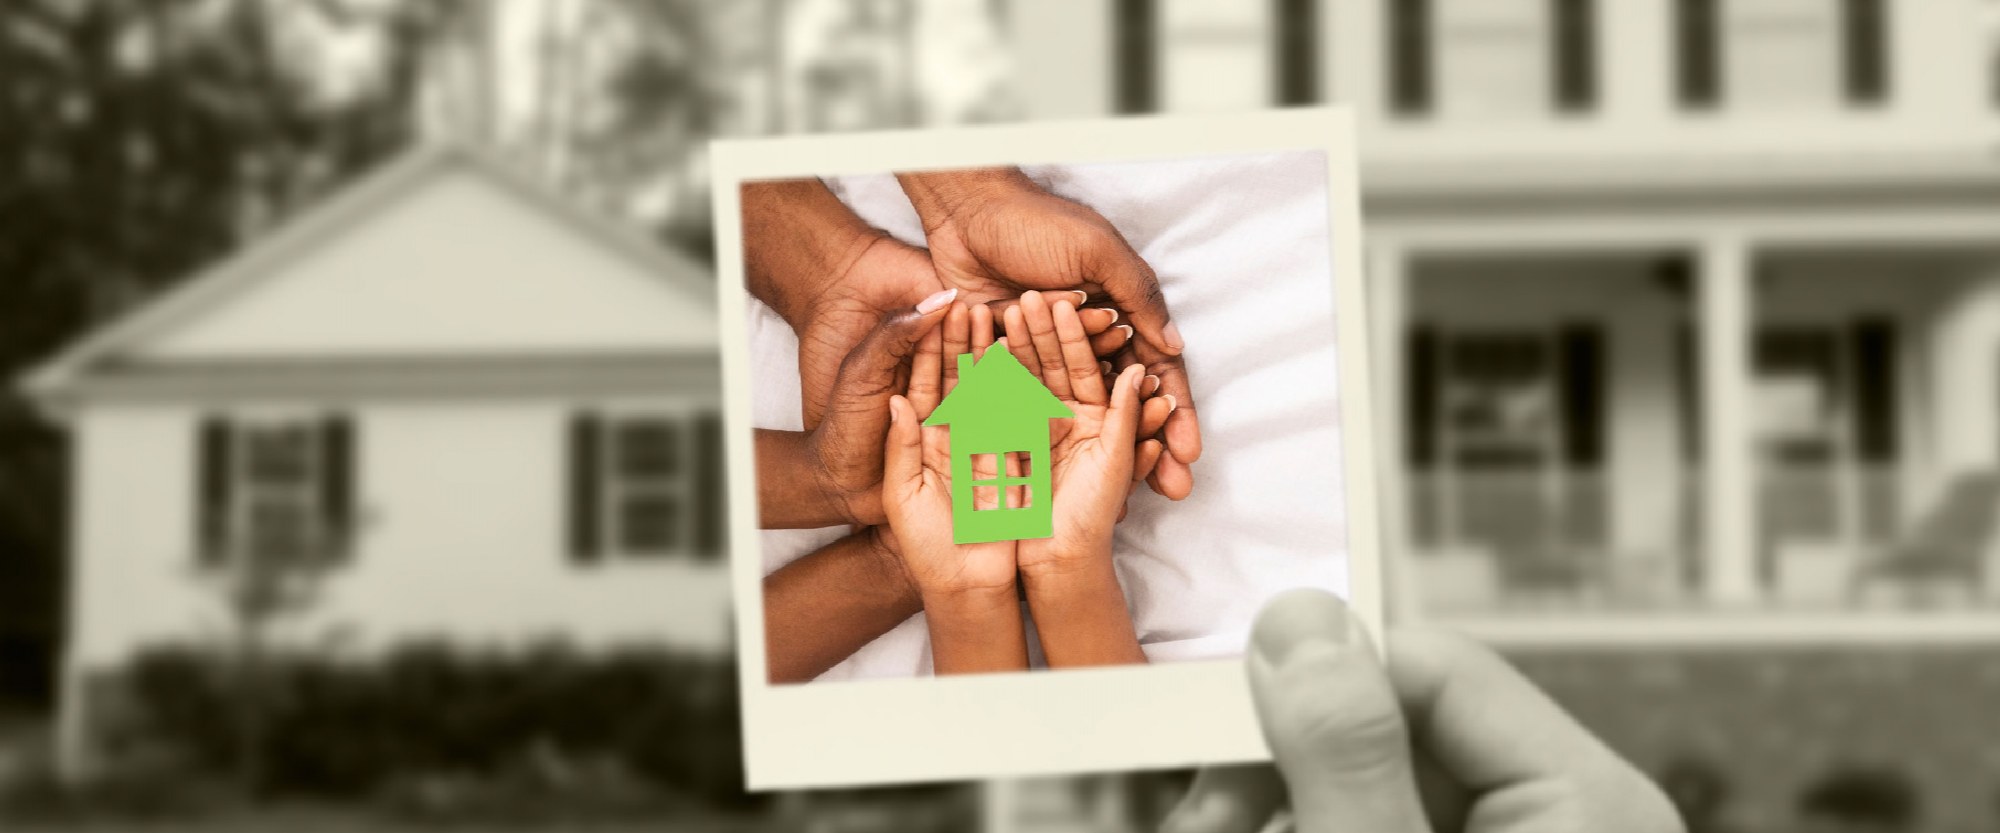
left=26, top=148, right=730, bottom=772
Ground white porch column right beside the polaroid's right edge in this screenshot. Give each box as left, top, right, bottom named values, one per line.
left=1364, top=236, right=1416, bottom=619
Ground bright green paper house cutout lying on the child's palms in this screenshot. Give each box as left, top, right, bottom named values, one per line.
left=924, top=342, right=1076, bottom=545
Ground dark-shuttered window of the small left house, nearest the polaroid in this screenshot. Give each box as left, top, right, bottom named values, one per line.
left=570, top=412, right=726, bottom=561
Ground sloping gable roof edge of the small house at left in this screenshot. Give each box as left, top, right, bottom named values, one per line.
left=20, top=144, right=716, bottom=408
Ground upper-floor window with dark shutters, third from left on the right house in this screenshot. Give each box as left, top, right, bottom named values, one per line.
left=1674, top=0, right=1890, bottom=110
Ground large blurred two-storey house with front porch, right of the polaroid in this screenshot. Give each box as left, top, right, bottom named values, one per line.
left=1006, top=0, right=2000, bottom=829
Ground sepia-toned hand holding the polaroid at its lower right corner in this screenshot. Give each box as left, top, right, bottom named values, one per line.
left=1164, top=591, right=1682, bottom=833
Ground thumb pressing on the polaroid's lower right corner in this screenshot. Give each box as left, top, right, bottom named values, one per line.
left=1248, top=589, right=1430, bottom=833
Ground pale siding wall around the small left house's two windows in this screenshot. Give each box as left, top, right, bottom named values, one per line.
left=72, top=400, right=730, bottom=663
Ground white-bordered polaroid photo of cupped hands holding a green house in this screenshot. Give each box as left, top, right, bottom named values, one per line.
left=712, top=108, right=1384, bottom=789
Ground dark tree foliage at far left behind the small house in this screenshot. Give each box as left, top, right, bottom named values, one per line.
left=0, top=0, right=424, bottom=712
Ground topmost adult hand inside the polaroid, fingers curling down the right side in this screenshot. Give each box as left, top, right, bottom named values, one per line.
left=898, top=168, right=1202, bottom=501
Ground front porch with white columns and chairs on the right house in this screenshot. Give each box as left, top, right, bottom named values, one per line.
left=1370, top=240, right=2000, bottom=616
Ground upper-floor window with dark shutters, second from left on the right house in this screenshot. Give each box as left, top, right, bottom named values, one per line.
left=1386, top=0, right=1598, bottom=116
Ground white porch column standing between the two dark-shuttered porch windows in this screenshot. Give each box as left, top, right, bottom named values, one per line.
left=1696, top=236, right=1760, bottom=605
